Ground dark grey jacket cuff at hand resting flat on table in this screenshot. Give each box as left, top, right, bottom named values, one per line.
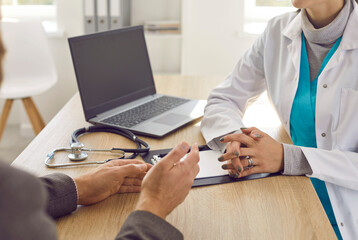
left=40, top=173, right=77, bottom=218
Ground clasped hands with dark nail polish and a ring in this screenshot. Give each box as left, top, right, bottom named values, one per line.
left=219, top=128, right=283, bottom=177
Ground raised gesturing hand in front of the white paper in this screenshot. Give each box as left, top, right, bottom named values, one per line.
left=136, top=142, right=199, bottom=219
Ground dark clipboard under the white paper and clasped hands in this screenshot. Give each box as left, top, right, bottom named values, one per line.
left=141, top=145, right=281, bottom=187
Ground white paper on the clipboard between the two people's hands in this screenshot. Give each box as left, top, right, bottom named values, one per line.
left=195, top=150, right=229, bottom=179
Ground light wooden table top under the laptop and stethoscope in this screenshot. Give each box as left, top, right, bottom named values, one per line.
left=13, top=76, right=335, bottom=240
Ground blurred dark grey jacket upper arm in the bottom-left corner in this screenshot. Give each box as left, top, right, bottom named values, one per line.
left=0, top=160, right=57, bottom=240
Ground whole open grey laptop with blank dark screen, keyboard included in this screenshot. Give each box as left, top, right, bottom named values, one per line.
left=68, top=26, right=206, bottom=137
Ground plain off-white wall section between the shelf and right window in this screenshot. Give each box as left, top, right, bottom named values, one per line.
left=182, top=0, right=257, bottom=75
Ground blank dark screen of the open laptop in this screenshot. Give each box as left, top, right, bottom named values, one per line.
left=69, top=26, right=156, bottom=120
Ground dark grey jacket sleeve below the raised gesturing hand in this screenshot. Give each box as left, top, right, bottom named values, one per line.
left=116, top=211, right=183, bottom=240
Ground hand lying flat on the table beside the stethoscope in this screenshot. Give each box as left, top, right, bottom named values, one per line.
left=74, top=159, right=151, bottom=205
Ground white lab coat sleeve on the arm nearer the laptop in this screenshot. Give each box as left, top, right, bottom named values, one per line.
left=201, top=27, right=266, bottom=150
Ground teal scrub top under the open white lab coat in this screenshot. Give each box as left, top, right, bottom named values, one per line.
left=290, top=32, right=342, bottom=239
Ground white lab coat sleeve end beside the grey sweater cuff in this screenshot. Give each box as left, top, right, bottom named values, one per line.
left=301, top=147, right=358, bottom=191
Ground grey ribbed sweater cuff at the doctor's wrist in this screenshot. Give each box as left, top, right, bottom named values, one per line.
left=282, top=144, right=312, bottom=175
